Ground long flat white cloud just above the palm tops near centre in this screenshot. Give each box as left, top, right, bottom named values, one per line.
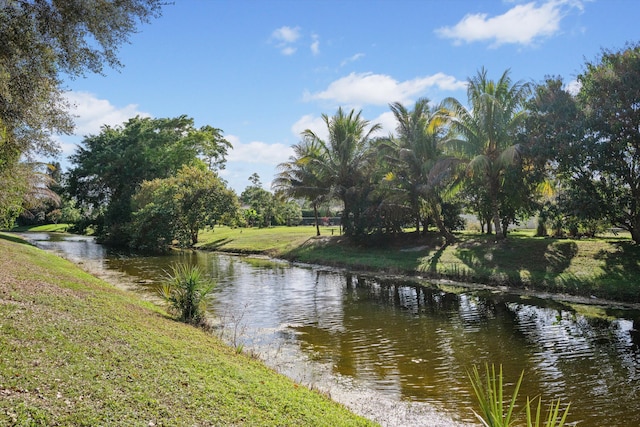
left=304, top=73, right=466, bottom=105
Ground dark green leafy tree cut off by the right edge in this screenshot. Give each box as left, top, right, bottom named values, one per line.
left=577, top=45, right=640, bottom=243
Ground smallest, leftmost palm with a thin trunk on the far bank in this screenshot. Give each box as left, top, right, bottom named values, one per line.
left=271, top=140, right=329, bottom=236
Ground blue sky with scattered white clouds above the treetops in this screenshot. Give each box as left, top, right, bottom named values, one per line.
left=59, top=0, right=640, bottom=194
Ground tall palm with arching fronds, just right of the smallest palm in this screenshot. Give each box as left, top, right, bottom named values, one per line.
left=302, top=107, right=381, bottom=235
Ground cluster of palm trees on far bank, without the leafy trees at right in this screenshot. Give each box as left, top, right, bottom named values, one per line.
left=274, top=69, right=531, bottom=242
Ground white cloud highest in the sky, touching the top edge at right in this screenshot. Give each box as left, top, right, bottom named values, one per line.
left=435, top=0, right=582, bottom=47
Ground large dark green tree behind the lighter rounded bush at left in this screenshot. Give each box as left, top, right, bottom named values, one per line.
left=68, top=116, right=228, bottom=245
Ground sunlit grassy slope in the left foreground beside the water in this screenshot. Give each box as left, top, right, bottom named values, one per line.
left=0, top=234, right=371, bottom=426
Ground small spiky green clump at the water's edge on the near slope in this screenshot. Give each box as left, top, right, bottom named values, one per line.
left=159, top=264, right=215, bottom=327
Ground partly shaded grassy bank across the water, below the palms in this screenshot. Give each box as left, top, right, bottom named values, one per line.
left=200, top=227, right=640, bottom=303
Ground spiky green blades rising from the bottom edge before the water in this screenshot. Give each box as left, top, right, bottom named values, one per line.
left=469, top=364, right=570, bottom=427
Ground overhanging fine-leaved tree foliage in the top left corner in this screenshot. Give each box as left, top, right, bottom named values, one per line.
left=0, top=0, right=162, bottom=227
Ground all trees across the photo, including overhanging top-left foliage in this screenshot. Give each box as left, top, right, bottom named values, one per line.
left=0, top=12, right=640, bottom=250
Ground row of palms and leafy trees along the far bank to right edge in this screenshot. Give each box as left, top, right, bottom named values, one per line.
left=274, top=45, right=640, bottom=246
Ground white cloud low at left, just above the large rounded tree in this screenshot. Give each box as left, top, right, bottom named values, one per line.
left=65, top=92, right=151, bottom=135
